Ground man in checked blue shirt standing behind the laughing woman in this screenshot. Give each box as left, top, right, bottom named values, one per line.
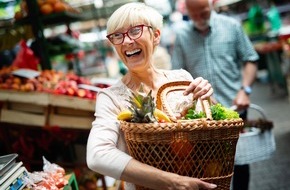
left=171, top=0, right=259, bottom=190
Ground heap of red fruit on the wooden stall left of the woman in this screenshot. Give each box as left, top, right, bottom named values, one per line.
left=0, top=66, right=102, bottom=99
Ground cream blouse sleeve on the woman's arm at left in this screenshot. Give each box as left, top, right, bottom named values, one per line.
left=86, top=90, right=132, bottom=179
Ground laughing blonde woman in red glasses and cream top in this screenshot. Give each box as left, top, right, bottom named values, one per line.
left=87, top=3, right=216, bottom=190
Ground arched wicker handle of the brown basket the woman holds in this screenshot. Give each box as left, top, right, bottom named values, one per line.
left=156, top=81, right=212, bottom=120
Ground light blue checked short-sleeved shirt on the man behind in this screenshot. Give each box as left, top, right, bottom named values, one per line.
left=171, top=12, right=259, bottom=107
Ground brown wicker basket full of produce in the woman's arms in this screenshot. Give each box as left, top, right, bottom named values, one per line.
left=120, top=81, right=243, bottom=190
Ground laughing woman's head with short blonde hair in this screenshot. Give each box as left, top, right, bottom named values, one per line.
left=107, top=3, right=163, bottom=73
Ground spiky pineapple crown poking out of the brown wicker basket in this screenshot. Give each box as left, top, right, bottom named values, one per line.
left=128, top=85, right=157, bottom=123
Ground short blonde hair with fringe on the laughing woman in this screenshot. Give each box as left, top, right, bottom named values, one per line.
left=107, top=2, right=163, bottom=34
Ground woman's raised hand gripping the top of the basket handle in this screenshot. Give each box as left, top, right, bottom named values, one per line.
left=183, top=77, right=213, bottom=100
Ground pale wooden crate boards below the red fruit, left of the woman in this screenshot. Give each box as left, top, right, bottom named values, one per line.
left=0, top=90, right=95, bottom=129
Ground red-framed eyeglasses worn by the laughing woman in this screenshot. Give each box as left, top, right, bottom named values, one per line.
left=106, top=24, right=152, bottom=45
